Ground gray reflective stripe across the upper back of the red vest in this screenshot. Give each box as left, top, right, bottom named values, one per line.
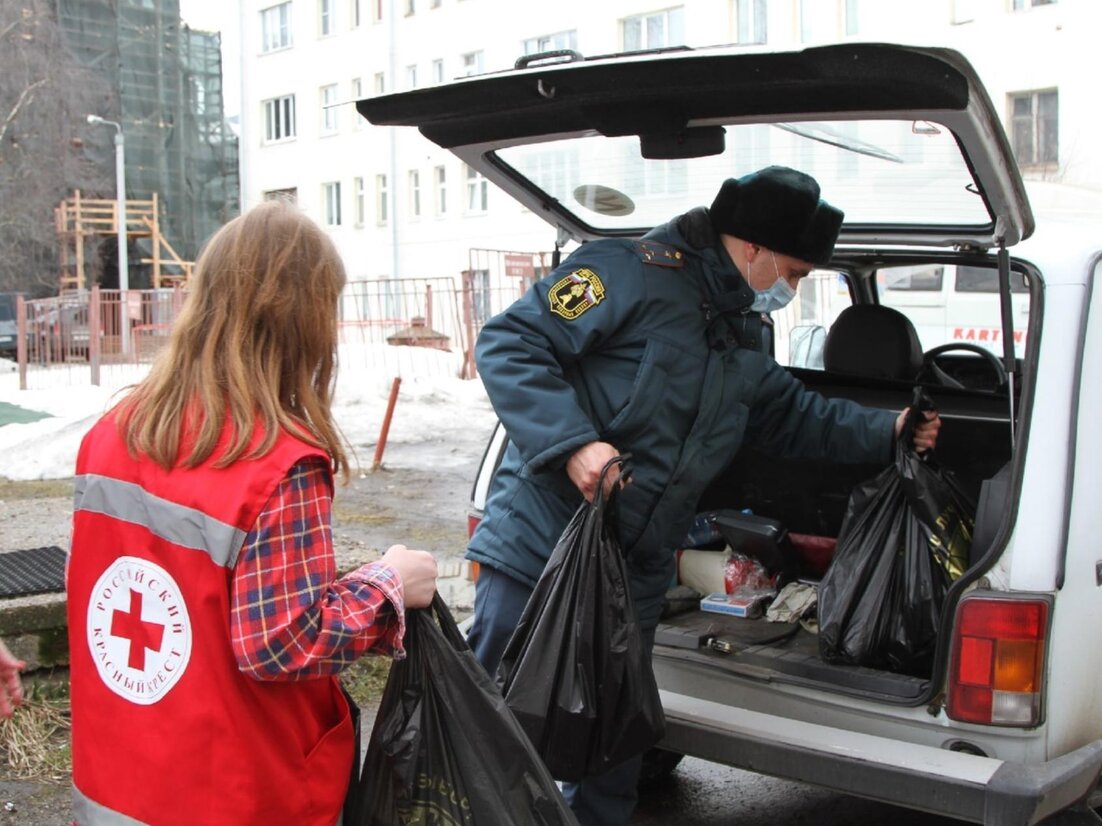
left=73, top=474, right=247, bottom=567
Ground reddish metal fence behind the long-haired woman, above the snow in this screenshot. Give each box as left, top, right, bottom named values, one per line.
left=8, top=268, right=533, bottom=390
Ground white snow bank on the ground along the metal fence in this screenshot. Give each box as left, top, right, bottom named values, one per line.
left=0, top=345, right=495, bottom=480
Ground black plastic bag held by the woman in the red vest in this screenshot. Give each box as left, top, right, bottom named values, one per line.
left=344, top=595, right=577, bottom=826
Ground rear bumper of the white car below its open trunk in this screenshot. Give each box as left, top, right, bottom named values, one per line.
left=660, top=691, right=1102, bottom=826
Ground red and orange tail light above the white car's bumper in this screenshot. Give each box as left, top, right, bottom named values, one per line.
left=946, top=597, right=1049, bottom=726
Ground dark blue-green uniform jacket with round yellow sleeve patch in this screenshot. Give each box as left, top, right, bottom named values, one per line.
left=467, top=209, right=895, bottom=626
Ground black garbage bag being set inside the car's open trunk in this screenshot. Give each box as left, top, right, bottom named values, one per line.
left=819, top=388, right=975, bottom=676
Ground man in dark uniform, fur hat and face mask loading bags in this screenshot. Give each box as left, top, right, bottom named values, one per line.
left=467, top=166, right=940, bottom=826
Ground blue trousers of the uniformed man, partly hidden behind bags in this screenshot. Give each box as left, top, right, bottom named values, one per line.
left=467, top=565, right=655, bottom=826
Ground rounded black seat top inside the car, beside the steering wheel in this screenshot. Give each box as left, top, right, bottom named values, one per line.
left=823, top=304, right=922, bottom=381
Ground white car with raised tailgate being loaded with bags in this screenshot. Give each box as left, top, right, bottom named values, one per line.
left=358, top=44, right=1102, bottom=826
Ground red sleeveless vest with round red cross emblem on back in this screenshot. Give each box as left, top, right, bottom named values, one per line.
left=67, top=414, right=354, bottom=826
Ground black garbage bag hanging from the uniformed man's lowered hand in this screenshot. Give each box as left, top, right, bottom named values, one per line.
left=498, top=454, right=666, bottom=781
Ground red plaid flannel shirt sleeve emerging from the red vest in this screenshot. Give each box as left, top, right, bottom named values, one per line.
left=230, top=459, right=406, bottom=681
